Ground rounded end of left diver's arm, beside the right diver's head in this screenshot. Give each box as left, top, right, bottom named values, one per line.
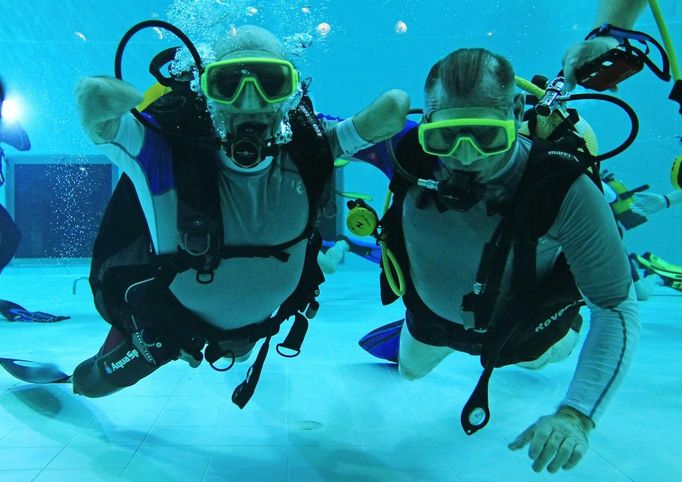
left=353, top=89, right=410, bottom=143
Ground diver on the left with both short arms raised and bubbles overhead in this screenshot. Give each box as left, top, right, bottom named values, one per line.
left=72, top=25, right=409, bottom=407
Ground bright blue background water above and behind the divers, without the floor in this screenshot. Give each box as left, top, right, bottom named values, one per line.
left=0, top=0, right=682, bottom=256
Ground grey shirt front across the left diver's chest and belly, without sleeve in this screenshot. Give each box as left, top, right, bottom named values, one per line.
left=169, top=155, right=309, bottom=328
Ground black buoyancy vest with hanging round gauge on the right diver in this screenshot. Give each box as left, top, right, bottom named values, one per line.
left=380, top=123, right=601, bottom=434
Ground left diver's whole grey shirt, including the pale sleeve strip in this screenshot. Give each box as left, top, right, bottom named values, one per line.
left=100, top=115, right=309, bottom=329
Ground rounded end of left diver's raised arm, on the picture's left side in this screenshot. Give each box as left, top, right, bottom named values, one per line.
left=76, top=76, right=143, bottom=144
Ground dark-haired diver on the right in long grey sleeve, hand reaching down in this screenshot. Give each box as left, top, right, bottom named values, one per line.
left=356, top=49, right=639, bottom=472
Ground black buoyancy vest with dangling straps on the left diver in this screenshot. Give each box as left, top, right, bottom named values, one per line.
left=90, top=83, right=333, bottom=407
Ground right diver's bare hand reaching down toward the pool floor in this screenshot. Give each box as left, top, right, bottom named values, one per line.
left=509, top=407, right=594, bottom=473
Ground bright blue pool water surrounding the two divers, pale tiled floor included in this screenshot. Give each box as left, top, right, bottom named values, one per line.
left=0, top=0, right=682, bottom=481
